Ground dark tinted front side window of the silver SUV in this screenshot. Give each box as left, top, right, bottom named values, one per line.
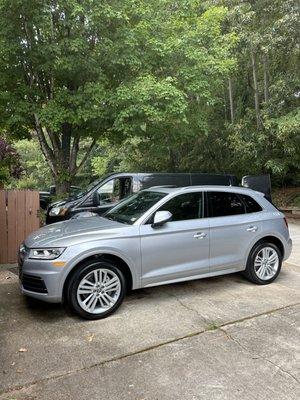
left=157, top=193, right=202, bottom=221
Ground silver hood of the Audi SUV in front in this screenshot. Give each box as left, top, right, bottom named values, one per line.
left=25, top=216, right=137, bottom=248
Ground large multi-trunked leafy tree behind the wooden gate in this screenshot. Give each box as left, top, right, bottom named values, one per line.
left=0, top=0, right=236, bottom=193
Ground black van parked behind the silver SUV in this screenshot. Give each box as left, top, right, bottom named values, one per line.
left=46, top=173, right=270, bottom=224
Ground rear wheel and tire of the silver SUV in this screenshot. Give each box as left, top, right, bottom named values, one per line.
left=243, top=242, right=282, bottom=285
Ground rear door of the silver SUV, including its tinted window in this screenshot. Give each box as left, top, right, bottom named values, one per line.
left=207, top=191, right=261, bottom=272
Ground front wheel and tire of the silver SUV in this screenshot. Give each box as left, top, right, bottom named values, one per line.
left=66, top=261, right=126, bottom=320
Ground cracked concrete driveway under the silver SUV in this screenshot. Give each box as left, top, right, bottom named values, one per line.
left=0, top=220, right=300, bottom=400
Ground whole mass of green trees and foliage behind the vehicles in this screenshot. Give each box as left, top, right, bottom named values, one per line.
left=0, top=0, right=300, bottom=191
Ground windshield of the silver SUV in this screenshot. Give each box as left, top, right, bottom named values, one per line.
left=104, top=191, right=166, bottom=225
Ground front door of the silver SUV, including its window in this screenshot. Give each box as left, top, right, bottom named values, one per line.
left=140, top=192, right=209, bottom=286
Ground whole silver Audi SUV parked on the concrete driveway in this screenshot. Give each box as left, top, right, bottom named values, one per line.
left=19, top=186, right=292, bottom=319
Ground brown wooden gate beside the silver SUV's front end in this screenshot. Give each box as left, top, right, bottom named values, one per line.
left=0, top=190, right=40, bottom=264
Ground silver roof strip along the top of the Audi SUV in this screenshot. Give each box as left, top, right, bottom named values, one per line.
left=145, top=185, right=264, bottom=196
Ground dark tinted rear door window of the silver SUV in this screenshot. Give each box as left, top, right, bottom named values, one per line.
left=207, top=192, right=245, bottom=217
